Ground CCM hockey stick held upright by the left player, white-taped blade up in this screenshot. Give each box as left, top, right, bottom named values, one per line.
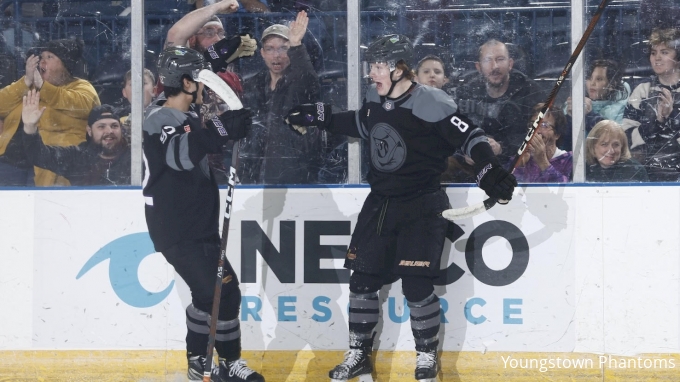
left=198, top=69, right=243, bottom=382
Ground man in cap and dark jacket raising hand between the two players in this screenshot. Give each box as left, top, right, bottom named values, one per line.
left=240, top=11, right=322, bottom=184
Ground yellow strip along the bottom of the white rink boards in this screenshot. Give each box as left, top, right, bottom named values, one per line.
left=0, top=350, right=680, bottom=382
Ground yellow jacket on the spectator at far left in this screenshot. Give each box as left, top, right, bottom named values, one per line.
left=0, top=77, right=100, bottom=186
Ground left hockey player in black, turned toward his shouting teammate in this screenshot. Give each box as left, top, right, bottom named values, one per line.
left=143, top=47, right=264, bottom=382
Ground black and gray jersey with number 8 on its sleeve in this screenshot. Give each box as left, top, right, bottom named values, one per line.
left=328, top=83, right=495, bottom=196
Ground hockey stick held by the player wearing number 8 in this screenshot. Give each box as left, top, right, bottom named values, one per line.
left=441, top=0, right=609, bottom=221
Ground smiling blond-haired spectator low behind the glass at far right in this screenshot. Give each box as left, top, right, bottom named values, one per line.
left=586, top=119, right=649, bottom=182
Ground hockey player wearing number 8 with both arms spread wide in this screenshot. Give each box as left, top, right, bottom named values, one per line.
left=286, top=35, right=517, bottom=382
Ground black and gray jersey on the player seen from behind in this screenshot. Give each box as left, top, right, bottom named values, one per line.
left=142, top=105, right=226, bottom=252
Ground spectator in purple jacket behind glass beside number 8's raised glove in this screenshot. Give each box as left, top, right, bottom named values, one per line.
left=513, top=103, right=573, bottom=183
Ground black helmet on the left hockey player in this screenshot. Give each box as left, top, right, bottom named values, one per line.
left=158, top=46, right=210, bottom=88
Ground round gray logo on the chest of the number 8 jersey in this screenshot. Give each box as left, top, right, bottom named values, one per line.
left=371, top=122, right=406, bottom=172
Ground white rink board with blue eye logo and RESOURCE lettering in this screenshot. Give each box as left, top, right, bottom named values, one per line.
left=0, top=186, right=680, bottom=380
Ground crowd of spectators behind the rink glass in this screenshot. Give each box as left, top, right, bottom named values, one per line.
left=0, top=0, right=680, bottom=187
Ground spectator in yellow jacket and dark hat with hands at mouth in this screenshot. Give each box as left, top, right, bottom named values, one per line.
left=0, top=40, right=100, bottom=186
